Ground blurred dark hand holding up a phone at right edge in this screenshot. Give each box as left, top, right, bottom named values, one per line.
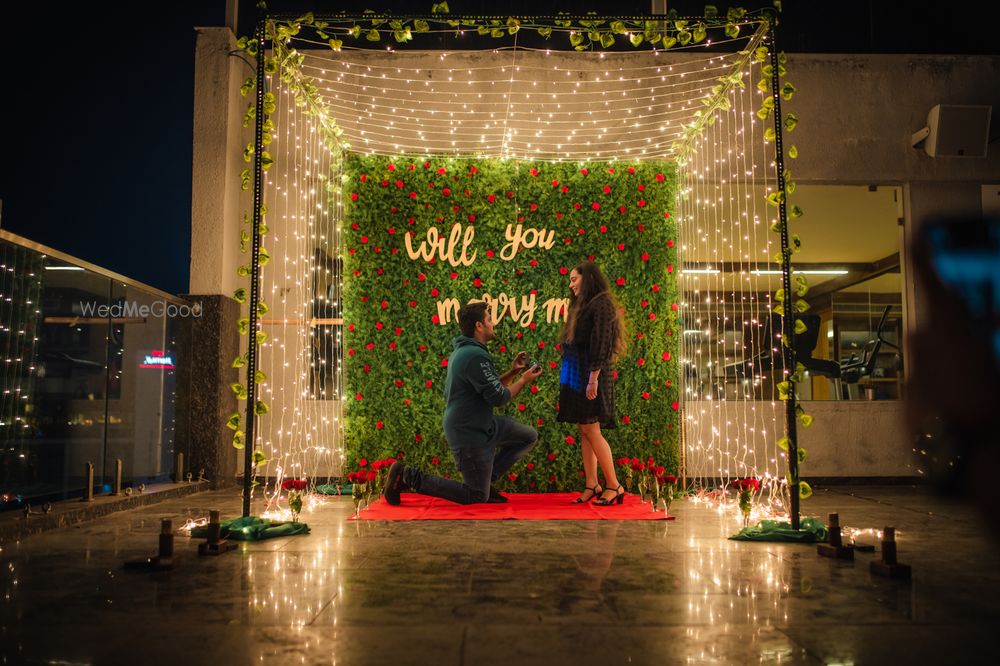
left=905, top=219, right=1000, bottom=498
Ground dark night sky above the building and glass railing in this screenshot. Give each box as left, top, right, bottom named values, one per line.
left=0, top=0, right=998, bottom=293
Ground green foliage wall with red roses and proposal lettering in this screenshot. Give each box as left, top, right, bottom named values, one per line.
left=342, top=154, right=683, bottom=491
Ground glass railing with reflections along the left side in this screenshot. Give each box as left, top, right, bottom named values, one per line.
left=0, top=231, right=188, bottom=510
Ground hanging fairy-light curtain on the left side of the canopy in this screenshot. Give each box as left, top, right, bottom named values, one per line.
left=255, top=70, right=344, bottom=519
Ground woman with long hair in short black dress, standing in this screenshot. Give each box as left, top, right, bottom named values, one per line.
left=557, top=261, right=625, bottom=506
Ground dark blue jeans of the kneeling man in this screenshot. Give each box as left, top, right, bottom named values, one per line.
left=417, top=416, right=538, bottom=504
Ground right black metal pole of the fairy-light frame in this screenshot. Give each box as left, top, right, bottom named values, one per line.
left=767, top=15, right=799, bottom=530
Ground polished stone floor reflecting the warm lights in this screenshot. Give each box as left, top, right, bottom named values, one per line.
left=0, top=487, right=1000, bottom=666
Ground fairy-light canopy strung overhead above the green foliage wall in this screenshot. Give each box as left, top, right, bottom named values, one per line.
left=303, top=49, right=752, bottom=160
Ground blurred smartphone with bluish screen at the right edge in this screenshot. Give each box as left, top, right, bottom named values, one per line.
left=923, top=218, right=1000, bottom=365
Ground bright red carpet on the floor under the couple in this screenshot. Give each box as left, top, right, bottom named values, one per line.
left=348, top=493, right=674, bottom=520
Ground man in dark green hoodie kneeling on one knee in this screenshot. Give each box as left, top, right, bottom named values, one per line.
left=383, top=302, right=542, bottom=505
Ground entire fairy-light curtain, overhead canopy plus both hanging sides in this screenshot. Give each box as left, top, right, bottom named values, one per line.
left=244, top=18, right=785, bottom=508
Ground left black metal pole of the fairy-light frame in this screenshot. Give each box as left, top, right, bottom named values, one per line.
left=243, top=19, right=266, bottom=517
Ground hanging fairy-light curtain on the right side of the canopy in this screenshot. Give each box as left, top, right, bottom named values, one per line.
left=678, top=45, right=787, bottom=516
